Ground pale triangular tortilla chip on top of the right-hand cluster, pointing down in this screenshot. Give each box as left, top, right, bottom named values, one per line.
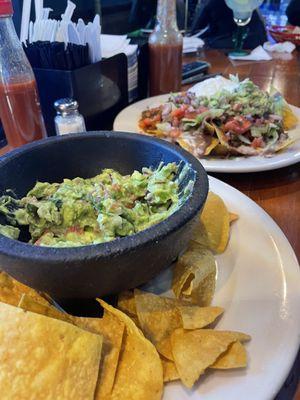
left=171, top=329, right=250, bottom=388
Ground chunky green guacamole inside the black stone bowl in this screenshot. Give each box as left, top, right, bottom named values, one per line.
left=0, top=163, right=180, bottom=247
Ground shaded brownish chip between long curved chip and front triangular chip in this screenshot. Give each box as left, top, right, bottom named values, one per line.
left=134, top=290, right=182, bottom=360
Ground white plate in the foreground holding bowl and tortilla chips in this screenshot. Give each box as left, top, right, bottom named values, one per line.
left=141, top=178, right=300, bottom=400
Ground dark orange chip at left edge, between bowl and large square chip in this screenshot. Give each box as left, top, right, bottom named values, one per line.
left=0, top=271, right=49, bottom=306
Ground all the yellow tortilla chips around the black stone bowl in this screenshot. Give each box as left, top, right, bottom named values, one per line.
left=0, top=193, right=250, bottom=400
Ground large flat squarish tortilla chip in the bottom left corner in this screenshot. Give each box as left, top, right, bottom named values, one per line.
left=0, top=303, right=102, bottom=400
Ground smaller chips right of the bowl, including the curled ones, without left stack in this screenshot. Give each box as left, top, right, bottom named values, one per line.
left=118, top=192, right=250, bottom=388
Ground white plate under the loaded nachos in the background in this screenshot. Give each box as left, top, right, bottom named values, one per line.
left=114, top=95, right=300, bottom=173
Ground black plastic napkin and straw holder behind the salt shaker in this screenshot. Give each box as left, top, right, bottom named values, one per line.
left=33, top=54, right=128, bottom=136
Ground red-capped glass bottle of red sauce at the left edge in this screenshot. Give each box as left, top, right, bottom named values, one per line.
left=0, top=0, right=46, bottom=151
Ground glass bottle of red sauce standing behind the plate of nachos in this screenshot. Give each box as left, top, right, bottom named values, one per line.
left=149, top=0, right=183, bottom=96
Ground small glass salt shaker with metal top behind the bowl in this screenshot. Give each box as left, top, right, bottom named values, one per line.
left=54, top=98, right=86, bottom=135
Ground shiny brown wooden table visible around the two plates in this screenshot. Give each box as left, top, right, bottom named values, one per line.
left=184, top=50, right=300, bottom=400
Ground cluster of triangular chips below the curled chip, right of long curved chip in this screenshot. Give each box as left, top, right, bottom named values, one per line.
left=118, top=289, right=250, bottom=388
